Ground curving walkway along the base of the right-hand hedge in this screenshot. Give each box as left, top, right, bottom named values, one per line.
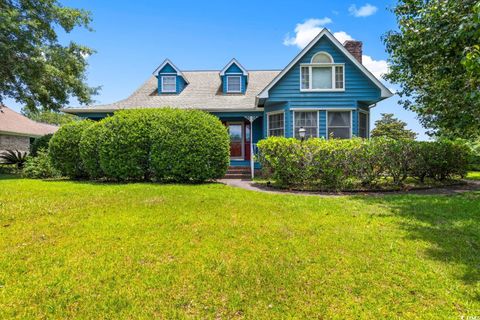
left=218, top=179, right=480, bottom=197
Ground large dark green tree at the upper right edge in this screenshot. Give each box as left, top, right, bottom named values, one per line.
left=383, top=0, right=480, bottom=138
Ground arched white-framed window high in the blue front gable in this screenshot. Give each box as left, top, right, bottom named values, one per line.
left=300, top=52, right=345, bottom=91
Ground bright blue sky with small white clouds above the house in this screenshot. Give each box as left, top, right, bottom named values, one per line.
left=9, top=0, right=426, bottom=139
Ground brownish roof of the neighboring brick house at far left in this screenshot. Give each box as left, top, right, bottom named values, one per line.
left=0, top=105, right=58, bottom=137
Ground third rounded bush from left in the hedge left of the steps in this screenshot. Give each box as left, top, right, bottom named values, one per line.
left=99, top=109, right=170, bottom=181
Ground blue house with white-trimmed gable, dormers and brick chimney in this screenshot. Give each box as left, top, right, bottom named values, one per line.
left=63, top=29, right=392, bottom=166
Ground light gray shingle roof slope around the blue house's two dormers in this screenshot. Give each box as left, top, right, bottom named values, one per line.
left=63, top=71, right=280, bottom=113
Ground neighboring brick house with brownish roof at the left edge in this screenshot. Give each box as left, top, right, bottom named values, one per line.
left=0, top=105, right=58, bottom=153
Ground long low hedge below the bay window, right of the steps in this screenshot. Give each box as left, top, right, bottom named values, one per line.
left=258, top=137, right=470, bottom=190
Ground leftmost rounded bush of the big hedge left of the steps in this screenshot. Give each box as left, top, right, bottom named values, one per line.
left=49, top=120, right=92, bottom=178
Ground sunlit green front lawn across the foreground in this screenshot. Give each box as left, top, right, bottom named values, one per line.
left=0, top=178, right=480, bottom=319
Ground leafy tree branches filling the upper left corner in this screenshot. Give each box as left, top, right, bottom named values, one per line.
left=0, top=0, right=98, bottom=111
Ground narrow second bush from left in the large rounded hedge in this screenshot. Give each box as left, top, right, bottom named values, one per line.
left=79, top=122, right=105, bottom=179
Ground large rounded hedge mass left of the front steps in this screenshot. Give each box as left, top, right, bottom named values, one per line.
left=50, top=108, right=230, bottom=183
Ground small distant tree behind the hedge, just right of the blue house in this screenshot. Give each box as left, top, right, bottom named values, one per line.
left=370, top=113, right=417, bottom=140
